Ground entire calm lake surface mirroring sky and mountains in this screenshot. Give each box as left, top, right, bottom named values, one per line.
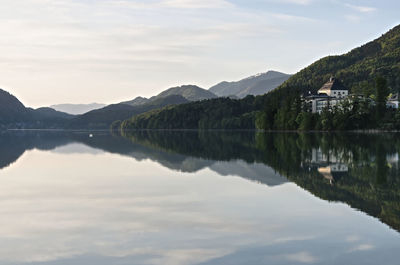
left=0, top=131, right=400, bottom=265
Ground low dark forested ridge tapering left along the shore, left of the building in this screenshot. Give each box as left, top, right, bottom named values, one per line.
left=121, top=96, right=264, bottom=130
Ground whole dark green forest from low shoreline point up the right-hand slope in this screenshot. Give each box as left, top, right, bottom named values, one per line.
left=120, top=25, right=400, bottom=130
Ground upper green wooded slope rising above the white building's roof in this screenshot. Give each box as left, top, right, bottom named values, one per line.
left=280, top=25, right=400, bottom=93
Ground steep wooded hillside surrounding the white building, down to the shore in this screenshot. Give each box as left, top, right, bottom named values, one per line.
left=257, top=26, right=400, bottom=131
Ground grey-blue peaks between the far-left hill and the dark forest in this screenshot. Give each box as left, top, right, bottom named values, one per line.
left=66, top=76, right=289, bottom=129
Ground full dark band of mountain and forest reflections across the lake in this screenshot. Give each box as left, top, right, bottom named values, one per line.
left=0, top=131, right=400, bottom=231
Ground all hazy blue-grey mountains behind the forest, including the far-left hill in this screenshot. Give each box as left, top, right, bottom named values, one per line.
left=0, top=67, right=289, bottom=129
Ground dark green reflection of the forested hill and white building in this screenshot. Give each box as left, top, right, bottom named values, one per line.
left=122, top=131, right=400, bottom=231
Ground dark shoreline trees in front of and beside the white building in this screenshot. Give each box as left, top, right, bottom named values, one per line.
left=256, top=77, right=400, bottom=131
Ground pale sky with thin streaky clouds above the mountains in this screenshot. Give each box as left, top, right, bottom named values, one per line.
left=0, top=0, right=400, bottom=107
